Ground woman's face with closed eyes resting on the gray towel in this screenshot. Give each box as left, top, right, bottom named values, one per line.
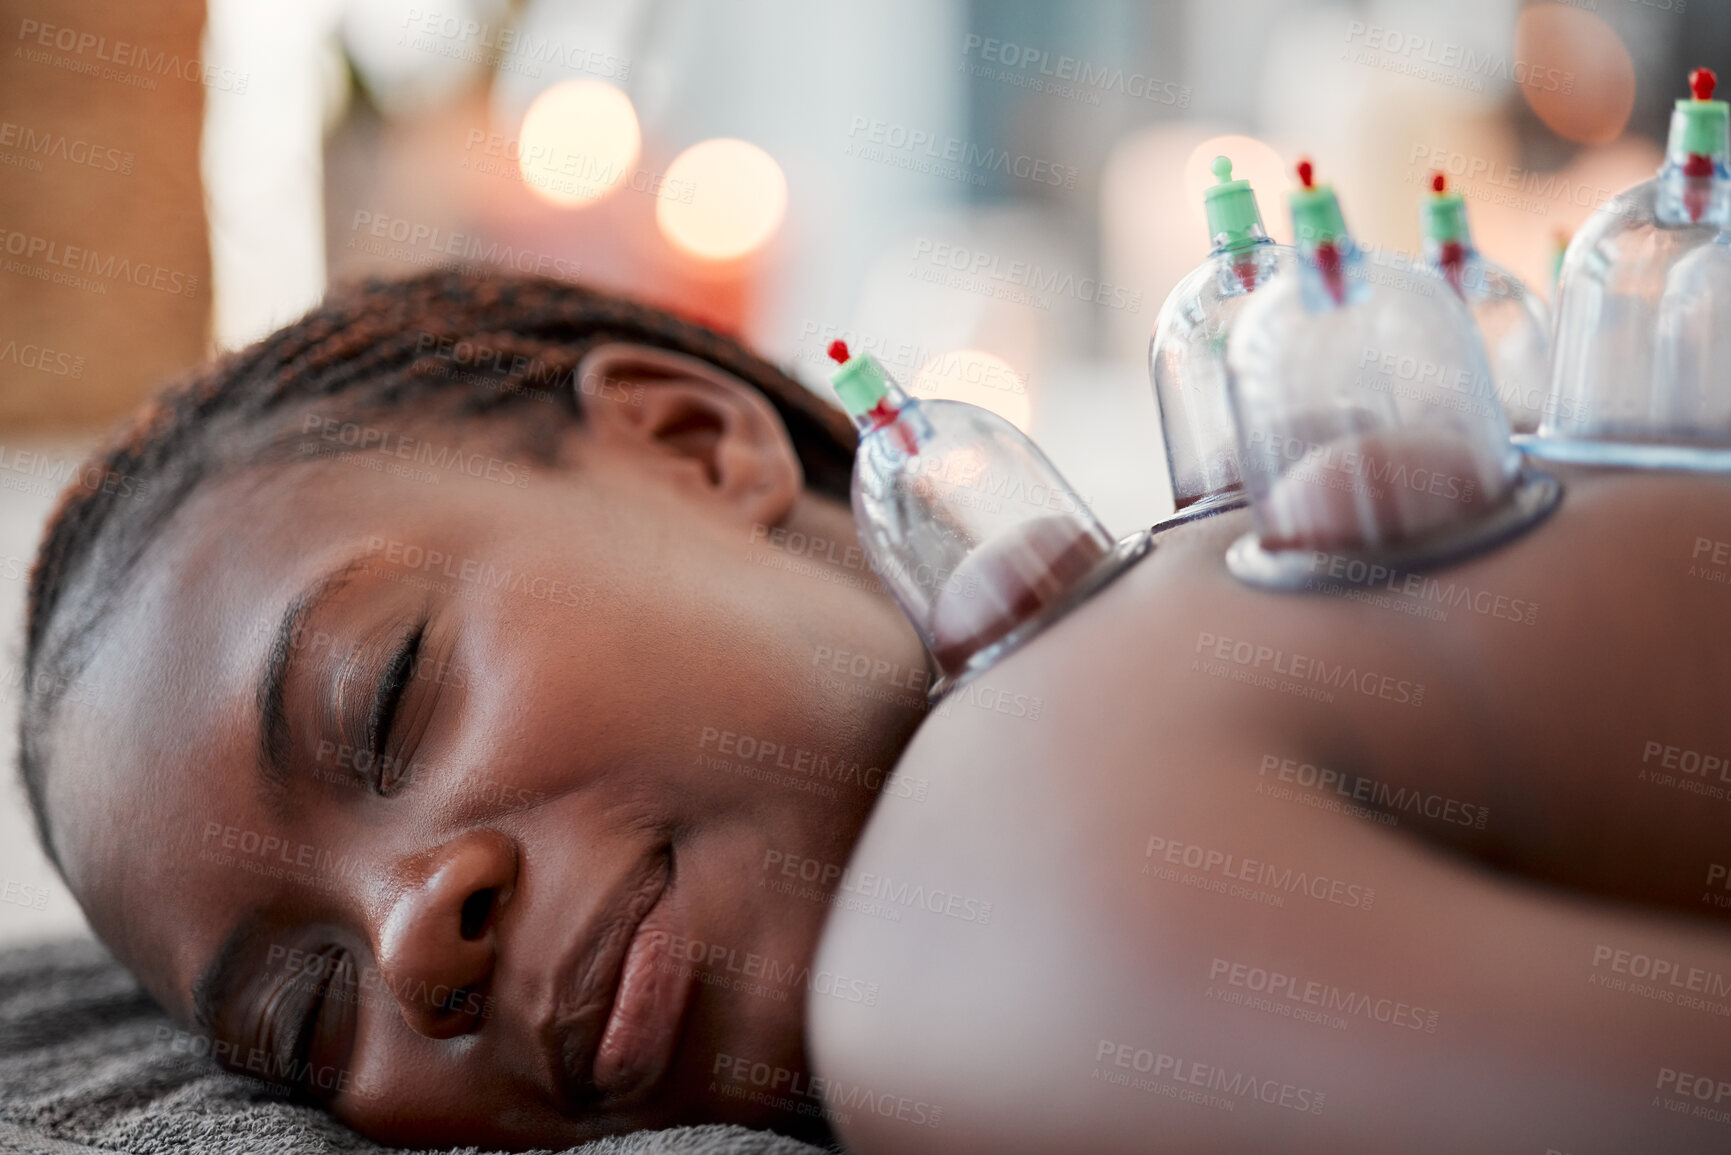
left=47, top=361, right=923, bottom=1145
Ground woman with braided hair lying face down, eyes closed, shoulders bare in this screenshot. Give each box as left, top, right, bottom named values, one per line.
left=23, top=274, right=1731, bottom=1152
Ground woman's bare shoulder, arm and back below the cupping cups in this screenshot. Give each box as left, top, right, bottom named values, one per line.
left=810, top=469, right=1731, bottom=1155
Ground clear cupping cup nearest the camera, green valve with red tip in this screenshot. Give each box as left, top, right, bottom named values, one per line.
left=1226, top=163, right=1558, bottom=589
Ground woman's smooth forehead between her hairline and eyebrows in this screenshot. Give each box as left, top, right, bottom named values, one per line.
left=45, top=469, right=426, bottom=1008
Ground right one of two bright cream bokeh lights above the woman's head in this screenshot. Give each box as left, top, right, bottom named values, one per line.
left=654, top=137, right=788, bottom=261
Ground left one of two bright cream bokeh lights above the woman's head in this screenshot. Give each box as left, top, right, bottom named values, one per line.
left=518, top=78, right=642, bottom=208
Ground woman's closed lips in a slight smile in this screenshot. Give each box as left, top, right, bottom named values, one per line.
left=549, top=855, right=691, bottom=1107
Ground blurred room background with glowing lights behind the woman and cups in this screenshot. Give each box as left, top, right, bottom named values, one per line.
left=0, top=0, right=1731, bottom=944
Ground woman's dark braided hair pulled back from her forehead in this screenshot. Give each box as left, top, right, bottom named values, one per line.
left=19, top=270, right=855, bottom=862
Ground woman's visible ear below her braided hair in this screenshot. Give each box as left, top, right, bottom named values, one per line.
left=576, top=341, right=805, bottom=525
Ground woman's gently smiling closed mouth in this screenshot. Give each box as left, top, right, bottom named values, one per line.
left=557, top=850, right=691, bottom=1107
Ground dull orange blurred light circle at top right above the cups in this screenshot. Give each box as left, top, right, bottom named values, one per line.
left=1515, top=3, right=1634, bottom=144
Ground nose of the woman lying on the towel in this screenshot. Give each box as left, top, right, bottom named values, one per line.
left=374, top=829, right=518, bottom=1039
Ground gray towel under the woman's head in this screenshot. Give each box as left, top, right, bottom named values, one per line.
left=0, top=939, right=822, bottom=1155
